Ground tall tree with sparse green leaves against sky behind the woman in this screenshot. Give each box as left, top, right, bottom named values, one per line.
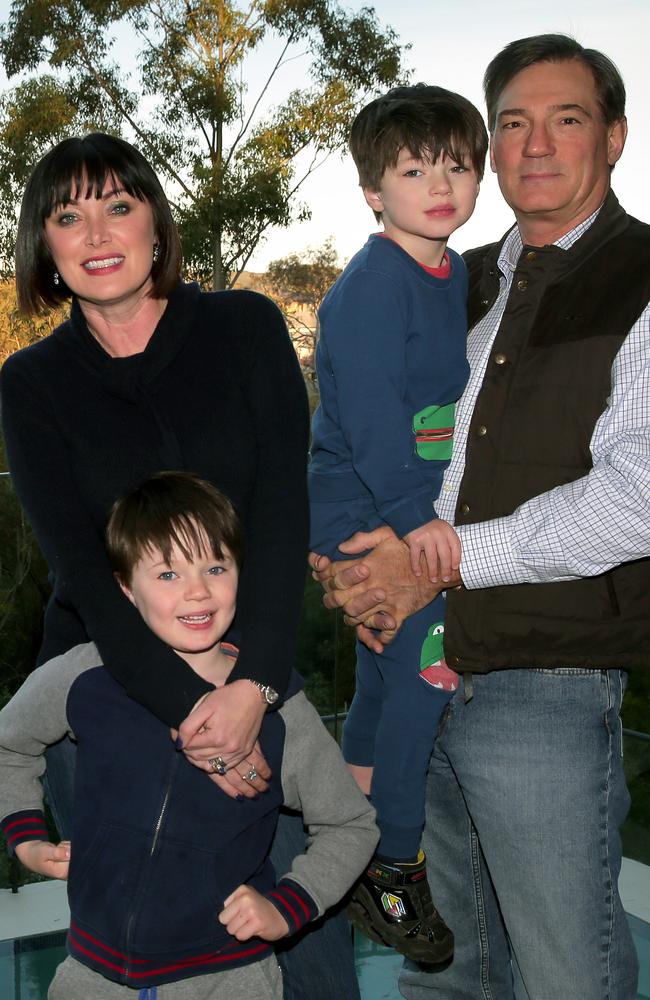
left=0, top=0, right=404, bottom=288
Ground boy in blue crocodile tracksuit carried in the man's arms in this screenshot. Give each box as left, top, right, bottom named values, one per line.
left=309, top=84, right=487, bottom=962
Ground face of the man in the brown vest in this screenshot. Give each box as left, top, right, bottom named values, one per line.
left=490, top=59, right=626, bottom=245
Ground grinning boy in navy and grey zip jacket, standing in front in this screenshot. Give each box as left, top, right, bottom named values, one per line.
left=0, top=473, right=377, bottom=1000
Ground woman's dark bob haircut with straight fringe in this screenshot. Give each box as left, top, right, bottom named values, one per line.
left=16, top=132, right=182, bottom=316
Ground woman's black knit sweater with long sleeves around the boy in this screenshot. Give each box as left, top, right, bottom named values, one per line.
left=0, top=285, right=308, bottom=726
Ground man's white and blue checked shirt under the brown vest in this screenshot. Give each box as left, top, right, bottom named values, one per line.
left=436, top=206, right=650, bottom=589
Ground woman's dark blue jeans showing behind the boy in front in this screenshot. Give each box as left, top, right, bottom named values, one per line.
left=46, top=739, right=359, bottom=1000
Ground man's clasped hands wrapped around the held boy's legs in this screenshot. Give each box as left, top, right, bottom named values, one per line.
left=309, top=525, right=462, bottom=653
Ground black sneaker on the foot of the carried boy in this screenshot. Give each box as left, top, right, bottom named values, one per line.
left=347, top=851, right=454, bottom=965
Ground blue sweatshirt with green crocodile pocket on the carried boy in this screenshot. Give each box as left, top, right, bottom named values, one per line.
left=309, top=235, right=469, bottom=555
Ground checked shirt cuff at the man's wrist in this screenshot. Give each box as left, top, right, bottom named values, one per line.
left=456, top=517, right=532, bottom=590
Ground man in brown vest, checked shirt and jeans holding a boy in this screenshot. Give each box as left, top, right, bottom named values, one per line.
left=312, top=35, right=650, bottom=1000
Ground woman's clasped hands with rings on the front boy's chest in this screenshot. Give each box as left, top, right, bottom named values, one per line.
left=172, top=680, right=271, bottom=798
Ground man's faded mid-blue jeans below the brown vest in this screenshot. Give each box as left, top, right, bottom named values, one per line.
left=400, top=669, right=638, bottom=1000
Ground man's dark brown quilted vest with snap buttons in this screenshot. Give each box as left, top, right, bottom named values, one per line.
left=445, top=194, right=650, bottom=673
